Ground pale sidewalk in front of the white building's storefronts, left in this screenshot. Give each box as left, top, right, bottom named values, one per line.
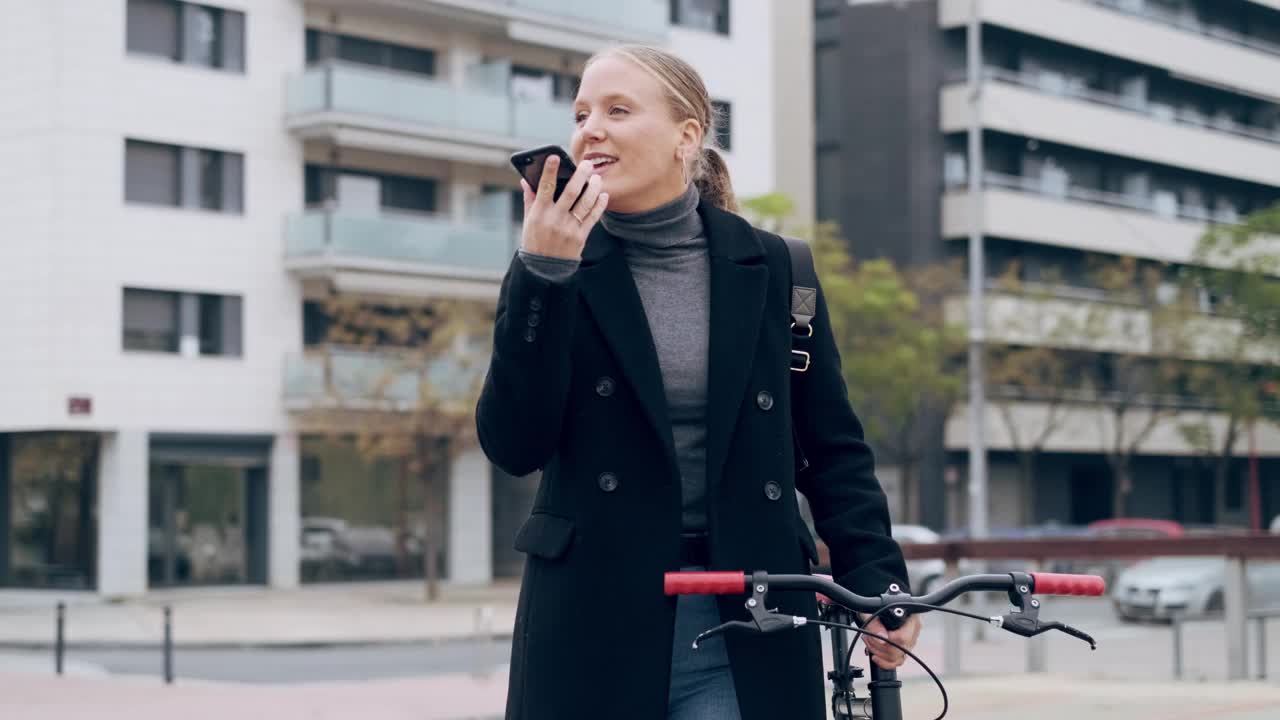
left=0, top=580, right=518, bottom=648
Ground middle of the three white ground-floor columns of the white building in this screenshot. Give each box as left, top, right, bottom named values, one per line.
left=266, top=433, right=302, bottom=589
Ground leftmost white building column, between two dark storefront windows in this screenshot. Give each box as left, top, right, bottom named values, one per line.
left=97, top=429, right=150, bottom=597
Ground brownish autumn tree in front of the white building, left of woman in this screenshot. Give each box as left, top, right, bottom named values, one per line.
left=305, top=295, right=493, bottom=601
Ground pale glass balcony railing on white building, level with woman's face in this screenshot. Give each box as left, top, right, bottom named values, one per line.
left=288, top=63, right=573, bottom=147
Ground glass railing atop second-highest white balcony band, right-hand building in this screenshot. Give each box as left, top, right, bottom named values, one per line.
left=947, top=67, right=1280, bottom=145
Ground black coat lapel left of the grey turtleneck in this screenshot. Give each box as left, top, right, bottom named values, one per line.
left=577, top=224, right=678, bottom=471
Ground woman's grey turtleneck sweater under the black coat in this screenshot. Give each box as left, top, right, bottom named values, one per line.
left=520, top=184, right=710, bottom=532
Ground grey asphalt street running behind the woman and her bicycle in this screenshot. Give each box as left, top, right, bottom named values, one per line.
left=0, top=597, right=1280, bottom=684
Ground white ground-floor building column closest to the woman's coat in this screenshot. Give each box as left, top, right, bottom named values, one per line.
left=448, top=447, right=493, bottom=584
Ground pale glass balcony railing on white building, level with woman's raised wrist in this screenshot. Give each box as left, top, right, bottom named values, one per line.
left=285, top=209, right=520, bottom=275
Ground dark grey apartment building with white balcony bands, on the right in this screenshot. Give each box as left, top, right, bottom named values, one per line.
left=814, top=0, right=1280, bottom=527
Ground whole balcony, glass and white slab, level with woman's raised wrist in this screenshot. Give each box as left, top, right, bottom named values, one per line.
left=285, top=210, right=518, bottom=300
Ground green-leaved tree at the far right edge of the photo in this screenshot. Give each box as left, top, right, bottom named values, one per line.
left=1180, top=205, right=1280, bottom=520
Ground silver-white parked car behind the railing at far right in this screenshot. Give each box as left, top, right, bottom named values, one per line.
left=1111, top=557, right=1280, bottom=620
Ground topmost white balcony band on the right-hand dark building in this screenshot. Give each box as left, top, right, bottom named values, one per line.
left=938, top=0, right=1280, bottom=101
